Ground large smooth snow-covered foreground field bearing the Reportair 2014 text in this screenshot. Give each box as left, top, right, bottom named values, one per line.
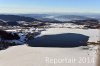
left=0, top=45, right=96, bottom=66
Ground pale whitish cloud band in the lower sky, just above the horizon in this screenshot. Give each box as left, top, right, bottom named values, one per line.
left=0, top=8, right=100, bottom=13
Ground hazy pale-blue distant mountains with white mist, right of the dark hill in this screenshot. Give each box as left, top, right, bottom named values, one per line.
left=21, top=14, right=99, bottom=22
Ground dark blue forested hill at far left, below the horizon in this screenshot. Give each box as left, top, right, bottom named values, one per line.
left=0, top=15, right=38, bottom=25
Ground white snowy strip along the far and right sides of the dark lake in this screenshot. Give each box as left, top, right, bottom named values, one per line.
left=37, top=28, right=100, bottom=43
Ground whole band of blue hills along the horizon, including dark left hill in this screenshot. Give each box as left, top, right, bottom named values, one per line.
left=0, top=14, right=100, bottom=25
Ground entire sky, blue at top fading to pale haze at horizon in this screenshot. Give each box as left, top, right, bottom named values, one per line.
left=0, top=0, right=100, bottom=13
